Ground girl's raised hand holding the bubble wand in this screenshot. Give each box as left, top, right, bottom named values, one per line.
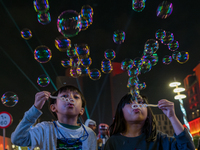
left=158, top=99, right=176, bottom=119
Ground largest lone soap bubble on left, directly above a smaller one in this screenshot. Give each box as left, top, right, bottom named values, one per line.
left=34, top=45, right=52, bottom=63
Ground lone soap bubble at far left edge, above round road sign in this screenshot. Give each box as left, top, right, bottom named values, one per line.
left=1, top=91, right=19, bottom=107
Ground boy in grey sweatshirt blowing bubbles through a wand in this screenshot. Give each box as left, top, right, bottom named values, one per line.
left=11, top=85, right=97, bottom=150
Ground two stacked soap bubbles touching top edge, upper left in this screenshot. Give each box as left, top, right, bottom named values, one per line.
left=33, top=0, right=51, bottom=25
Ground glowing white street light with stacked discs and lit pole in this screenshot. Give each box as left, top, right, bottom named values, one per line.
left=169, top=81, right=193, bottom=139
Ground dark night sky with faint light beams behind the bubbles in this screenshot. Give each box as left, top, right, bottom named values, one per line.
left=0, top=0, right=200, bottom=137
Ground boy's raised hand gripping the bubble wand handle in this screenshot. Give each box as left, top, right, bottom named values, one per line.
left=34, top=91, right=51, bottom=110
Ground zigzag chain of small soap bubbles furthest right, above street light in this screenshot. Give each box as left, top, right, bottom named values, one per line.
left=155, top=29, right=189, bottom=65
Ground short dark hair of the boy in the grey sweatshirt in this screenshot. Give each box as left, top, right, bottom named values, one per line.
left=48, top=85, right=86, bottom=119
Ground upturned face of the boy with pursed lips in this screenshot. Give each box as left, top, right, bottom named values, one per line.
left=51, top=90, right=84, bottom=119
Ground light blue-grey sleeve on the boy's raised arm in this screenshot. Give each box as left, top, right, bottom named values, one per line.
left=11, top=105, right=42, bottom=146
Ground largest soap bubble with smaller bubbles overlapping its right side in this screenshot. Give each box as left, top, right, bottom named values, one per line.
left=57, top=5, right=94, bottom=38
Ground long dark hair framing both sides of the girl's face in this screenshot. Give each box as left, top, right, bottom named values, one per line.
left=110, top=93, right=157, bottom=142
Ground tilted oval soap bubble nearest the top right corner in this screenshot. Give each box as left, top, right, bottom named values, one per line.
left=156, top=1, right=173, bottom=19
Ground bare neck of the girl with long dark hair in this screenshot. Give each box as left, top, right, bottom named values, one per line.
left=121, top=123, right=142, bottom=137
